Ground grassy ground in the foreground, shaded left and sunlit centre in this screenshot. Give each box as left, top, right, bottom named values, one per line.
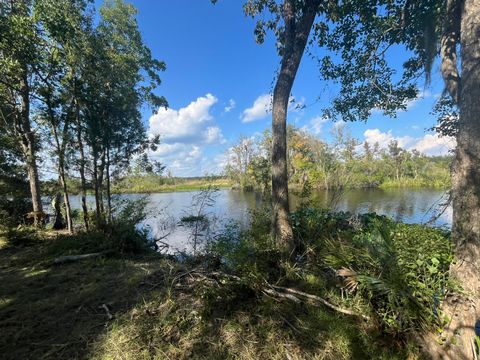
left=0, top=233, right=418, bottom=360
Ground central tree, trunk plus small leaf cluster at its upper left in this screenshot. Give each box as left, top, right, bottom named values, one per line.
left=245, top=0, right=321, bottom=256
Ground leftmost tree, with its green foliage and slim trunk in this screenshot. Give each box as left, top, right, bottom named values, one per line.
left=0, top=0, right=45, bottom=225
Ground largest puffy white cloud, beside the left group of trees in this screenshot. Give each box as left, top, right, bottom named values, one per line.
left=148, top=94, right=226, bottom=176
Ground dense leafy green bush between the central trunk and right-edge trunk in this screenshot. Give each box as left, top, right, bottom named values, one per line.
left=292, top=209, right=453, bottom=335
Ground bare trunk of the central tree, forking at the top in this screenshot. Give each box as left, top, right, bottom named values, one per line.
left=272, top=0, right=320, bottom=255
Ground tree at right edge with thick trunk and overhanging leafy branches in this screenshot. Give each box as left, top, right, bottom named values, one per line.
left=314, top=0, right=480, bottom=359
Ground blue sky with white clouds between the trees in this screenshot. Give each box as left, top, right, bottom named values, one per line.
left=96, top=0, right=454, bottom=176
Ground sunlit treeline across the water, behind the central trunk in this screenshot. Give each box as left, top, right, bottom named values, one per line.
left=225, top=126, right=452, bottom=190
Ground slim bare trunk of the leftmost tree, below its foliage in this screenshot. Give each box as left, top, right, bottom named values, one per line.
left=19, top=71, right=43, bottom=226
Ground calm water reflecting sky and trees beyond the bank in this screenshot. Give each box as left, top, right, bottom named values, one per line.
left=60, top=189, right=452, bottom=251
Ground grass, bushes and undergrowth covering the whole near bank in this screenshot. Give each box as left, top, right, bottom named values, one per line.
left=0, top=198, right=453, bottom=359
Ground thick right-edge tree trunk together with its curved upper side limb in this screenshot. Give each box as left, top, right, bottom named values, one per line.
left=428, top=0, right=480, bottom=360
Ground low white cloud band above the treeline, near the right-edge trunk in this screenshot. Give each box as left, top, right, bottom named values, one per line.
left=363, top=129, right=456, bottom=156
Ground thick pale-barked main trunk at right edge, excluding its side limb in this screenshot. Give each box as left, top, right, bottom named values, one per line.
left=452, top=0, right=480, bottom=358
